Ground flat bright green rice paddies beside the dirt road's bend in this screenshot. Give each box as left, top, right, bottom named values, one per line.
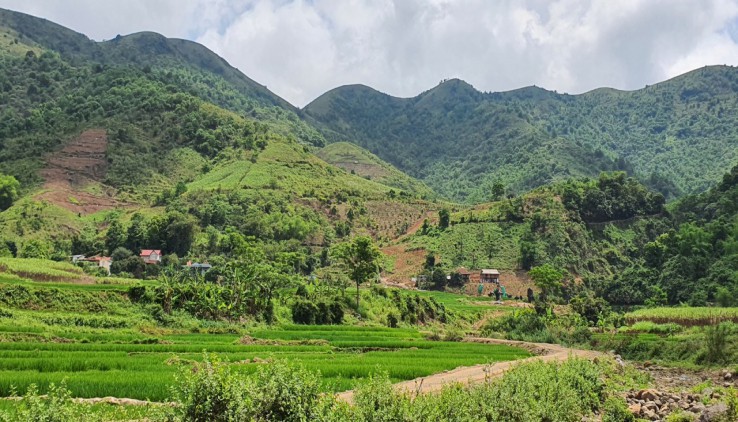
left=0, top=324, right=529, bottom=401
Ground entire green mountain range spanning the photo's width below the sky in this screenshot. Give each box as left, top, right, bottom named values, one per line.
left=0, top=6, right=738, bottom=303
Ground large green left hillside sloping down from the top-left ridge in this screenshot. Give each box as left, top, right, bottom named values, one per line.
left=0, top=11, right=432, bottom=277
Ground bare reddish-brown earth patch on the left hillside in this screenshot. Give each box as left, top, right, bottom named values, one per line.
left=36, top=129, right=128, bottom=214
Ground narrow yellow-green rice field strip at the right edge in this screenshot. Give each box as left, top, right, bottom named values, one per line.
left=625, top=307, right=738, bottom=327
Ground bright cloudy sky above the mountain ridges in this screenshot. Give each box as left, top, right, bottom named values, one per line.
left=0, top=0, right=738, bottom=106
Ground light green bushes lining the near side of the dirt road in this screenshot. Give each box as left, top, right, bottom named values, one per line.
left=350, top=359, right=606, bottom=422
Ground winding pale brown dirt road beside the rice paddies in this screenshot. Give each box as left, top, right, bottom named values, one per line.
left=336, top=337, right=602, bottom=403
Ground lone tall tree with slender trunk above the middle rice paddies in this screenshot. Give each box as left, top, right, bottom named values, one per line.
left=333, top=236, right=382, bottom=311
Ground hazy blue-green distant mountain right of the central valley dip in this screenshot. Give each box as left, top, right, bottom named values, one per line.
left=304, top=66, right=738, bottom=202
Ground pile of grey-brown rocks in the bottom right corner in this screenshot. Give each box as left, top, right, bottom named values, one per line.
left=626, top=389, right=728, bottom=422
